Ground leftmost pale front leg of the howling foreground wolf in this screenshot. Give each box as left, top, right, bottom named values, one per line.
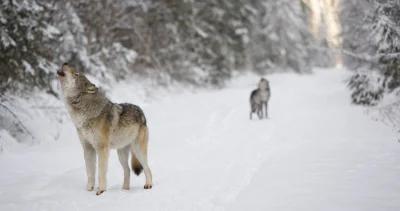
left=82, top=143, right=96, bottom=191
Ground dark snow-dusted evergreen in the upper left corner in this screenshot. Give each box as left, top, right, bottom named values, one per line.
left=0, top=0, right=60, bottom=92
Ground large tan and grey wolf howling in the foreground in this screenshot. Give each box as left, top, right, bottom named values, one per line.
left=57, top=63, right=152, bottom=195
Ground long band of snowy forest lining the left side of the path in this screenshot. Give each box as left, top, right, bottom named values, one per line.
left=0, top=0, right=318, bottom=94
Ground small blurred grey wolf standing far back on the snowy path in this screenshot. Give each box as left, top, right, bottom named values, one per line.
left=250, top=78, right=271, bottom=119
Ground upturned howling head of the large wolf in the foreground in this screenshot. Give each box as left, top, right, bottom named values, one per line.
left=57, top=63, right=98, bottom=97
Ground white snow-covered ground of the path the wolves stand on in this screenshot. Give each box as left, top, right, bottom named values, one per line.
left=0, top=70, right=400, bottom=211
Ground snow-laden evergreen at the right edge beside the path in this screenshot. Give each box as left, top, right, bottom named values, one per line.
left=344, top=0, right=400, bottom=105
